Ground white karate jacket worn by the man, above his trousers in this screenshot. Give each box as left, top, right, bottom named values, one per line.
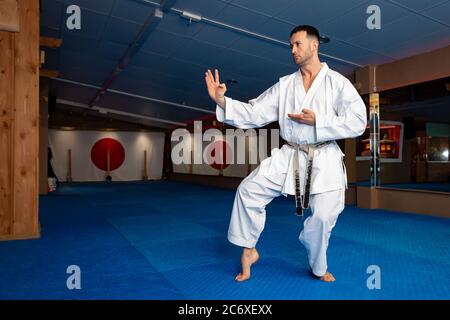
left=216, top=63, right=367, bottom=195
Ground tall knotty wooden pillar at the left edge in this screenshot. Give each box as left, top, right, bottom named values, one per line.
left=0, top=0, right=39, bottom=240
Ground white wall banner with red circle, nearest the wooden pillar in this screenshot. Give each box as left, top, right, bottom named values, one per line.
left=49, top=130, right=164, bottom=182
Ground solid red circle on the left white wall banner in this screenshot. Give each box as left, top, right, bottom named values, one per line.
left=91, top=138, right=125, bottom=171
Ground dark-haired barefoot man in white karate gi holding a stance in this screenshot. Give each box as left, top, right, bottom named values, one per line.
left=205, top=25, right=367, bottom=282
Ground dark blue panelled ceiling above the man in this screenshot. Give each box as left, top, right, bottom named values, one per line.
left=41, top=0, right=450, bottom=129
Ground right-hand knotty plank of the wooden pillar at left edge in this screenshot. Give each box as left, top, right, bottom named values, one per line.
left=13, top=0, right=40, bottom=237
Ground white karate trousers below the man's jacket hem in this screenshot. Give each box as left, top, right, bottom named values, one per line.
left=228, top=161, right=345, bottom=277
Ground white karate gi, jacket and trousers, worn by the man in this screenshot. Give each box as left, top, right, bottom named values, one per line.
left=216, top=63, right=367, bottom=276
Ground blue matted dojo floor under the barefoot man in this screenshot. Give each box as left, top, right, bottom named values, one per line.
left=0, top=181, right=450, bottom=299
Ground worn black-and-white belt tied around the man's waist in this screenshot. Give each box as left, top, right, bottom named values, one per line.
left=288, top=141, right=333, bottom=216
